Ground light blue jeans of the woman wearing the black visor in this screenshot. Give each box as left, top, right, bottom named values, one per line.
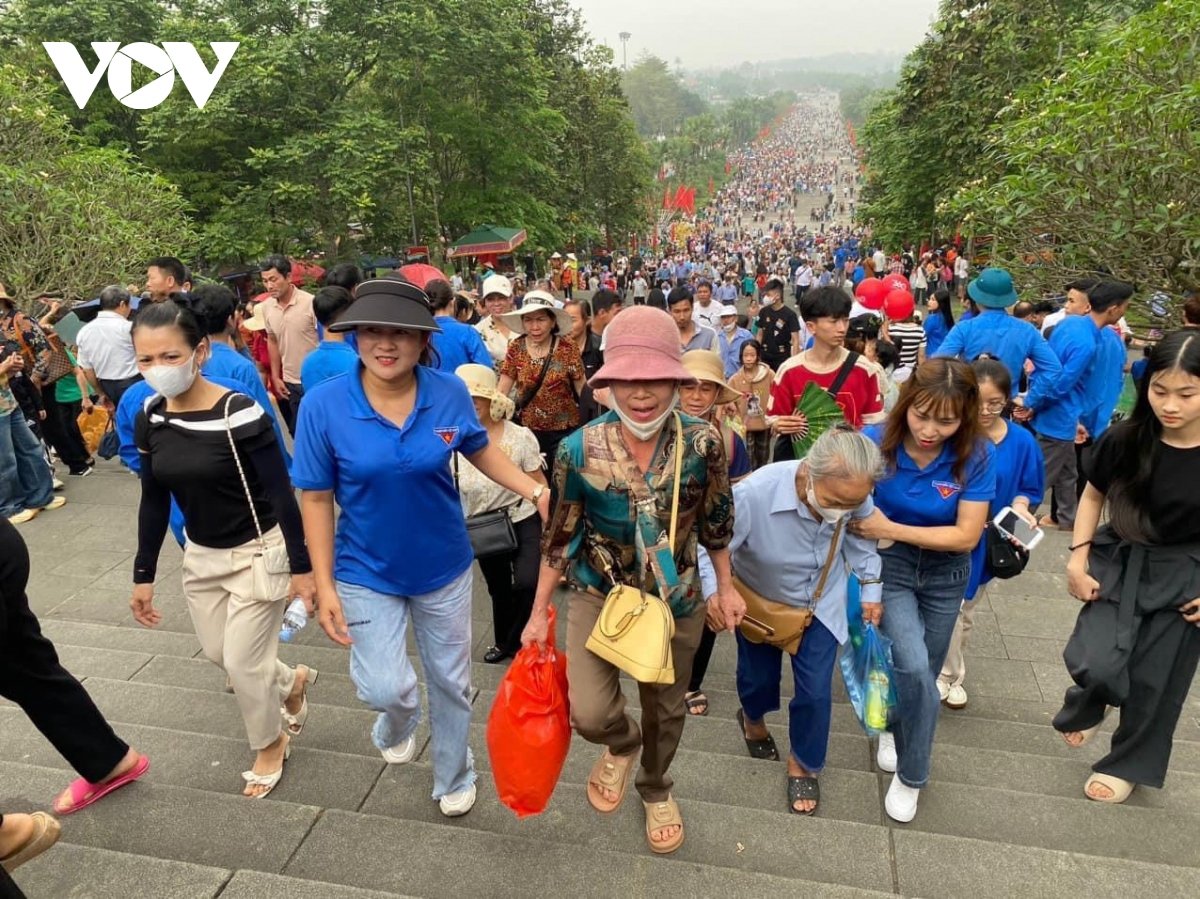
left=337, top=568, right=475, bottom=799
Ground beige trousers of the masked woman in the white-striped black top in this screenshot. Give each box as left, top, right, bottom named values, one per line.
left=184, top=527, right=295, bottom=751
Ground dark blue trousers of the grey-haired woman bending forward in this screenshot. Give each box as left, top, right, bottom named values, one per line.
left=736, top=618, right=838, bottom=774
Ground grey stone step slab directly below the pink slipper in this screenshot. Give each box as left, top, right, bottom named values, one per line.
left=0, top=760, right=322, bottom=868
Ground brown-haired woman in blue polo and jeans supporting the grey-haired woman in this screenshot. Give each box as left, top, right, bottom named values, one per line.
left=850, top=358, right=996, bottom=821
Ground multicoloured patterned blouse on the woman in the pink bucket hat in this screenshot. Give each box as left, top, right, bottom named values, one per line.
left=541, top=412, right=733, bottom=618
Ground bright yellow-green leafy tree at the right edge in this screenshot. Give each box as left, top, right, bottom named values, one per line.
left=943, top=0, right=1200, bottom=303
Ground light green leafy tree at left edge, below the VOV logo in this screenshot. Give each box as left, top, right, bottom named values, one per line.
left=0, top=65, right=194, bottom=298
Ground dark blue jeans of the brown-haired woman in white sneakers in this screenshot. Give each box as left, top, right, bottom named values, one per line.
left=880, top=543, right=971, bottom=787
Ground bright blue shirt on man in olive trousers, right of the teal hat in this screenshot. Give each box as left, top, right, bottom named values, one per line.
left=1025, top=316, right=1100, bottom=440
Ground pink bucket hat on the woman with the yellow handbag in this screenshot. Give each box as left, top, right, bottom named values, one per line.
left=588, top=306, right=696, bottom=388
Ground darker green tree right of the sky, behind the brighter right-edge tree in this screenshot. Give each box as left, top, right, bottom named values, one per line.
left=859, top=0, right=1153, bottom=245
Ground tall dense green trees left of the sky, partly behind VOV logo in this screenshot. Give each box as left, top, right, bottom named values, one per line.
left=0, top=0, right=652, bottom=265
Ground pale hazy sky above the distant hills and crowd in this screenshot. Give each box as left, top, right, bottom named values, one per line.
left=571, top=0, right=937, bottom=68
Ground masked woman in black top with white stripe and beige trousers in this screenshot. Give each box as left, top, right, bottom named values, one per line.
left=130, top=301, right=317, bottom=798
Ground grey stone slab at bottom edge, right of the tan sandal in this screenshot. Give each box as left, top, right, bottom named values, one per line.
left=12, top=840, right=230, bottom=899
